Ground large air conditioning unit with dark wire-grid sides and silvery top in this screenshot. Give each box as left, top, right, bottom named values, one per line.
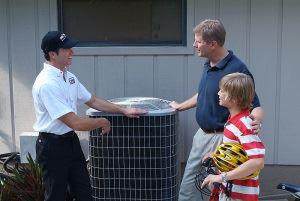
left=87, top=97, right=178, bottom=201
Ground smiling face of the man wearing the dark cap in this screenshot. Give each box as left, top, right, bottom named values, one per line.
left=52, top=48, right=73, bottom=68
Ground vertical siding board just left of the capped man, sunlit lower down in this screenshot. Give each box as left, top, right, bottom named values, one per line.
left=10, top=0, right=36, bottom=147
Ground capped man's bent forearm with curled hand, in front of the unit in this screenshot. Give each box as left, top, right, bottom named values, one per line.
left=58, top=112, right=110, bottom=134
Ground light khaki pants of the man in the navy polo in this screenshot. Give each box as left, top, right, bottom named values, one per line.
left=178, top=129, right=223, bottom=201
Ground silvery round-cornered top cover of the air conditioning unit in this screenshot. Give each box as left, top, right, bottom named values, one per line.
left=86, top=97, right=176, bottom=116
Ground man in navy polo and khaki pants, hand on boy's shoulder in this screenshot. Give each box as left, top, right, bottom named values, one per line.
left=170, top=20, right=263, bottom=201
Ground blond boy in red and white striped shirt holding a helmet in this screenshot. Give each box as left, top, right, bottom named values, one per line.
left=201, top=73, right=265, bottom=201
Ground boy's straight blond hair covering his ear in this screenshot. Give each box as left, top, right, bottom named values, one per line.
left=219, top=73, right=255, bottom=110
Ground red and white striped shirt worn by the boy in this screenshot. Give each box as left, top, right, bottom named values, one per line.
left=223, top=110, right=265, bottom=201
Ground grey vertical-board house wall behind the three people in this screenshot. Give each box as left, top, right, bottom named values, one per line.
left=0, top=0, right=300, bottom=165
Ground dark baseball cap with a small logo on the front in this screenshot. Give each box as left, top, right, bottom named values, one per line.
left=41, top=31, right=78, bottom=53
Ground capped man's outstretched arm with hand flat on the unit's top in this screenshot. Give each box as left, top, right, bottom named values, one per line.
left=85, top=96, right=146, bottom=117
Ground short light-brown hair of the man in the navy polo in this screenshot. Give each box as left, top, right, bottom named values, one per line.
left=193, top=19, right=226, bottom=47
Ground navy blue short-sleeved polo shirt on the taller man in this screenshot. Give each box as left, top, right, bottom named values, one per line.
left=196, top=50, right=260, bottom=130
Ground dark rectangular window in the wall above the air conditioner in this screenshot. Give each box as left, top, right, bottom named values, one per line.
left=58, top=0, right=186, bottom=46
